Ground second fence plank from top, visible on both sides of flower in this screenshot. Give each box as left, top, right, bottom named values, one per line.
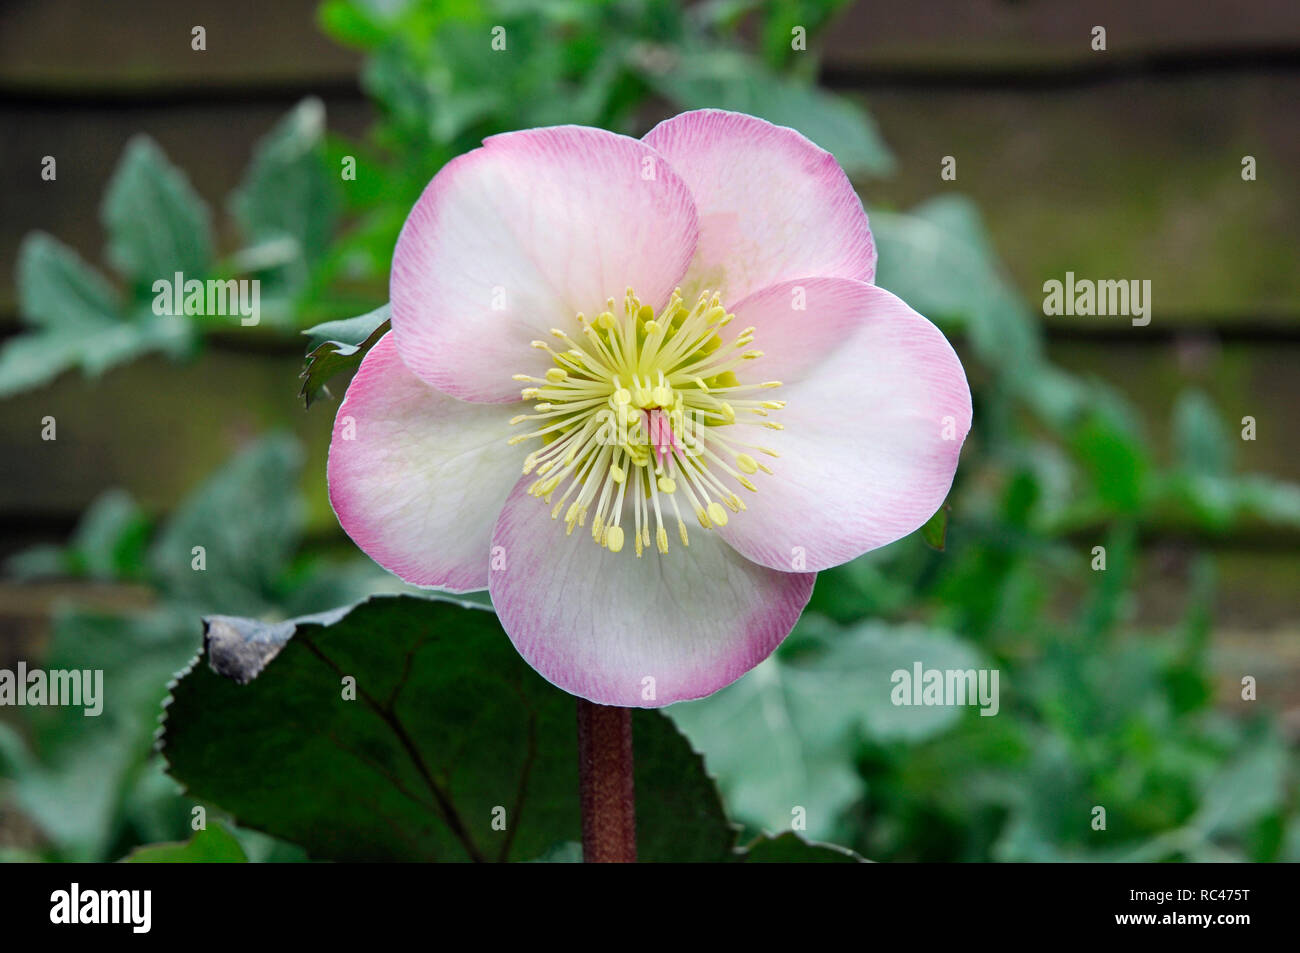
left=0, top=75, right=1300, bottom=323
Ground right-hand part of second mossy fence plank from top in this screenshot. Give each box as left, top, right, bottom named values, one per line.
left=862, top=75, right=1300, bottom=323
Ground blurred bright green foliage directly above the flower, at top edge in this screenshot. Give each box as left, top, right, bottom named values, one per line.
left=312, top=0, right=893, bottom=294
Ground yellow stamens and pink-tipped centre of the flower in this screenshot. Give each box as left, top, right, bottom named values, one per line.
left=510, top=289, right=785, bottom=556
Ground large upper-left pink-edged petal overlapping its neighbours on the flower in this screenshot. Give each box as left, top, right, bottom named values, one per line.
left=391, top=126, right=697, bottom=402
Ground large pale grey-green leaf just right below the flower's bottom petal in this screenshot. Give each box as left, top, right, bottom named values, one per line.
left=670, top=613, right=980, bottom=837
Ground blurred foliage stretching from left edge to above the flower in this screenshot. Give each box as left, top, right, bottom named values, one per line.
left=0, top=0, right=893, bottom=403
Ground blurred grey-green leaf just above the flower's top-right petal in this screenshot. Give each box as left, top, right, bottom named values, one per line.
left=642, top=51, right=894, bottom=176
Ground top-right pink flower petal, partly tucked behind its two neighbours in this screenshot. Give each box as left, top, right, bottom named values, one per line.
left=645, top=109, right=876, bottom=304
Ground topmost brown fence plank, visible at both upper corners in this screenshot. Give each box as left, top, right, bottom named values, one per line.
left=0, top=0, right=1300, bottom=90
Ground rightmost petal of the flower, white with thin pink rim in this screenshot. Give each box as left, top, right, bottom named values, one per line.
left=719, top=278, right=971, bottom=571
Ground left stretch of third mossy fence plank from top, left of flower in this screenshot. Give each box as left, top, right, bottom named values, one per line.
left=0, top=348, right=337, bottom=527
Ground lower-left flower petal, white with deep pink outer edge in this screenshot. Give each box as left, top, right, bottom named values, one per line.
left=328, top=333, right=525, bottom=592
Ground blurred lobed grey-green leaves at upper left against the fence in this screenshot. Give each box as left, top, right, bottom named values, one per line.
left=0, top=99, right=339, bottom=397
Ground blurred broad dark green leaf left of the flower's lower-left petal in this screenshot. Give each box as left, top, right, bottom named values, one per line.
left=150, top=436, right=303, bottom=612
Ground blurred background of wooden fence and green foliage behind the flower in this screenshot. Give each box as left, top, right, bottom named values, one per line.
left=0, top=0, right=1300, bottom=861
